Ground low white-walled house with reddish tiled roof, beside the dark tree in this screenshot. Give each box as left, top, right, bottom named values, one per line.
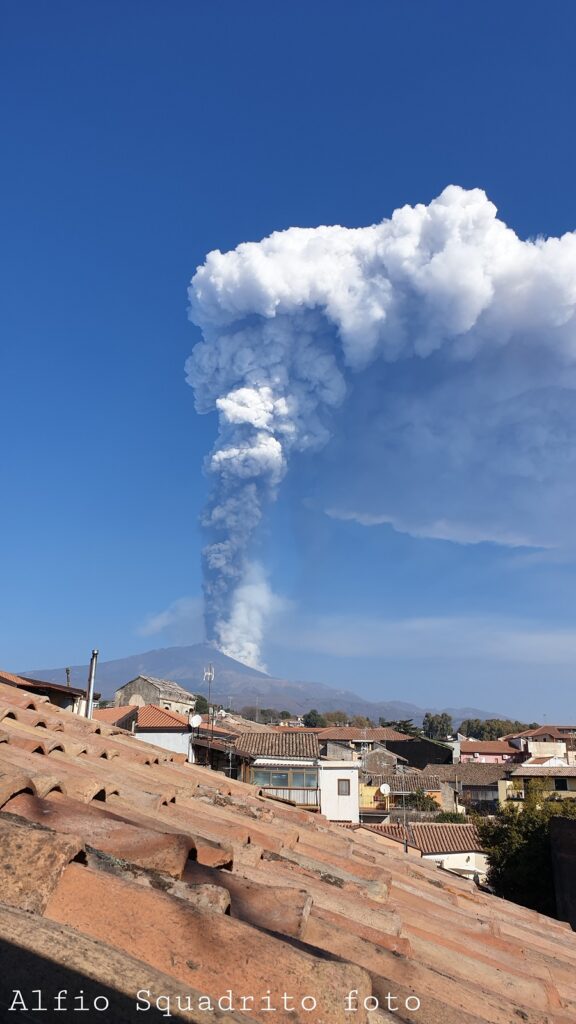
left=361, top=821, right=488, bottom=882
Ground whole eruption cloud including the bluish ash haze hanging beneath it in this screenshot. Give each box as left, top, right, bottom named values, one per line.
left=187, top=185, right=576, bottom=664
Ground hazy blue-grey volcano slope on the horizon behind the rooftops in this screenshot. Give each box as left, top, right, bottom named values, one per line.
left=23, top=644, right=502, bottom=724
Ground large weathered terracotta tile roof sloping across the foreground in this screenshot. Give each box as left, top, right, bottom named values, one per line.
left=0, top=685, right=576, bottom=1024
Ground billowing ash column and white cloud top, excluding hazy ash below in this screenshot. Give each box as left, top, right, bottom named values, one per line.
left=187, top=185, right=576, bottom=666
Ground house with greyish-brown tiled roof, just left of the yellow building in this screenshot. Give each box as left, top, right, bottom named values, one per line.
left=424, top=761, right=513, bottom=813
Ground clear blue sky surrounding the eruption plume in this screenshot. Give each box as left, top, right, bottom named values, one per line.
left=0, top=0, right=576, bottom=721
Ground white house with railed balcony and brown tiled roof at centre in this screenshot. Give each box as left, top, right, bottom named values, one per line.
left=230, top=730, right=359, bottom=821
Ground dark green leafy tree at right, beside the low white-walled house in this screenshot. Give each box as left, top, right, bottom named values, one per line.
left=477, top=780, right=576, bottom=916
